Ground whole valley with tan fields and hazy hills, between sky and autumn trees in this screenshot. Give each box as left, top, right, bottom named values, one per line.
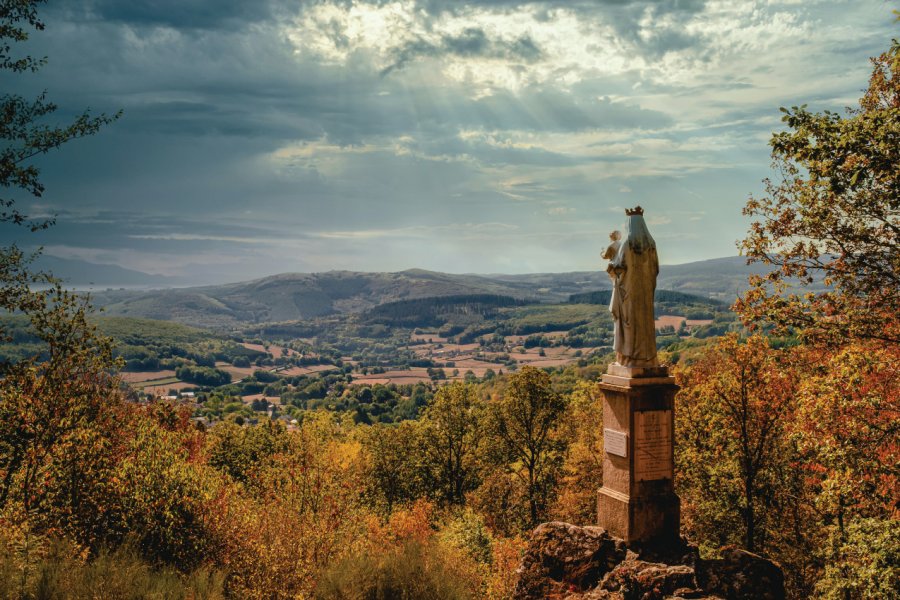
left=0, top=259, right=746, bottom=424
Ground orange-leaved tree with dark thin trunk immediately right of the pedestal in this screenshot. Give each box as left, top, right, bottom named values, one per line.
left=677, top=334, right=795, bottom=551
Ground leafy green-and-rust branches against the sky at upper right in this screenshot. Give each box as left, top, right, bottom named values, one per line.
left=737, top=40, right=900, bottom=344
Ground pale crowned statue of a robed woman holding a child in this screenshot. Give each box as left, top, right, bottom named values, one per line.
left=604, top=206, right=659, bottom=367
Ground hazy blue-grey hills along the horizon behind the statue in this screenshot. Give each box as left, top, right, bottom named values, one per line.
left=86, top=257, right=765, bottom=330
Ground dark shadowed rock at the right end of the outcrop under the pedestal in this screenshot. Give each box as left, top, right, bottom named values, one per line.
left=697, top=547, right=784, bottom=600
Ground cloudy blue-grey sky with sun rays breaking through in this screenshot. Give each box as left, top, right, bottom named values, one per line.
left=0, top=0, right=900, bottom=283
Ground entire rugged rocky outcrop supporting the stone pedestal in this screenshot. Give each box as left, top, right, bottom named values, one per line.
left=514, top=522, right=784, bottom=600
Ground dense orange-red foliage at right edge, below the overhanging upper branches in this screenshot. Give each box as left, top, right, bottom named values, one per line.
left=792, top=340, right=900, bottom=598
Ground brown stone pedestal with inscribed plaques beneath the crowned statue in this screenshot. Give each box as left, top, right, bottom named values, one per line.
left=597, top=365, right=681, bottom=544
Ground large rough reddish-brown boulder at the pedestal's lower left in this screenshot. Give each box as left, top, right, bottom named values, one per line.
left=514, top=522, right=625, bottom=600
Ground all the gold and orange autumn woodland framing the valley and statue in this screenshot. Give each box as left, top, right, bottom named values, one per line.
left=0, top=0, right=900, bottom=600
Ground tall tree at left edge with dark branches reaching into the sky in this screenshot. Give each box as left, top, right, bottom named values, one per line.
left=0, top=0, right=121, bottom=568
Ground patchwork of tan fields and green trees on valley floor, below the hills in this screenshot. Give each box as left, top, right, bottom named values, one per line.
left=93, top=292, right=733, bottom=424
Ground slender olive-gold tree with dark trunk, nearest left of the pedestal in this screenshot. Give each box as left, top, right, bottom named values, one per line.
left=491, top=366, right=566, bottom=527
